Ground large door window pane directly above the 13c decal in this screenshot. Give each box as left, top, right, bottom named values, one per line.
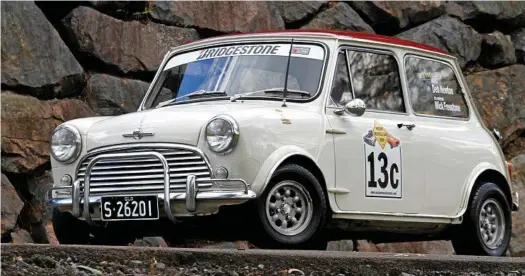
left=348, top=51, right=405, bottom=113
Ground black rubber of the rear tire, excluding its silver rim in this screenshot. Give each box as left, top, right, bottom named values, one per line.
left=451, top=182, right=512, bottom=257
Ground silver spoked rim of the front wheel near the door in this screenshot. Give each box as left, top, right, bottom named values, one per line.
left=265, top=180, right=313, bottom=236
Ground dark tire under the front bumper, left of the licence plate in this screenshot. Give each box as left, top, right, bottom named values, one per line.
left=52, top=208, right=91, bottom=244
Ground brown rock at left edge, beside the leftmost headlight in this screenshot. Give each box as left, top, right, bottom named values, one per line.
left=2, top=92, right=97, bottom=173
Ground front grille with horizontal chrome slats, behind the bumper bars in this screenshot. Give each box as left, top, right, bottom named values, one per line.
left=77, top=147, right=212, bottom=195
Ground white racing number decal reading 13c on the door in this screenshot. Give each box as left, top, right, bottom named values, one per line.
left=363, top=122, right=402, bottom=198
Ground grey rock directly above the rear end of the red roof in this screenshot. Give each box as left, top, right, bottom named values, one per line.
left=397, top=15, right=482, bottom=68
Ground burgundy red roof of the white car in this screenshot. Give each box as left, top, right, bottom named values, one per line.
left=190, top=29, right=449, bottom=55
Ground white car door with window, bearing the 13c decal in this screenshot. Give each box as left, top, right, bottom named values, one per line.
left=326, top=48, right=425, bottom=214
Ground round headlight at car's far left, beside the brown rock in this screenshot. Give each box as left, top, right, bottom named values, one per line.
left=51, top=125, right=82, bottom=163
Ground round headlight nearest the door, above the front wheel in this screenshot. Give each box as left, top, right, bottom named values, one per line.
left=205, top=115, right=239, bottom=154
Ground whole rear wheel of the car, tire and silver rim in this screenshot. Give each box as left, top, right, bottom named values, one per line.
left=452, top=182, right=512, bottom=256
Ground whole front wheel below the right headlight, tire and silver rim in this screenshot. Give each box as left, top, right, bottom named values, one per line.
left=257, top=164, right=327, bottom=250
